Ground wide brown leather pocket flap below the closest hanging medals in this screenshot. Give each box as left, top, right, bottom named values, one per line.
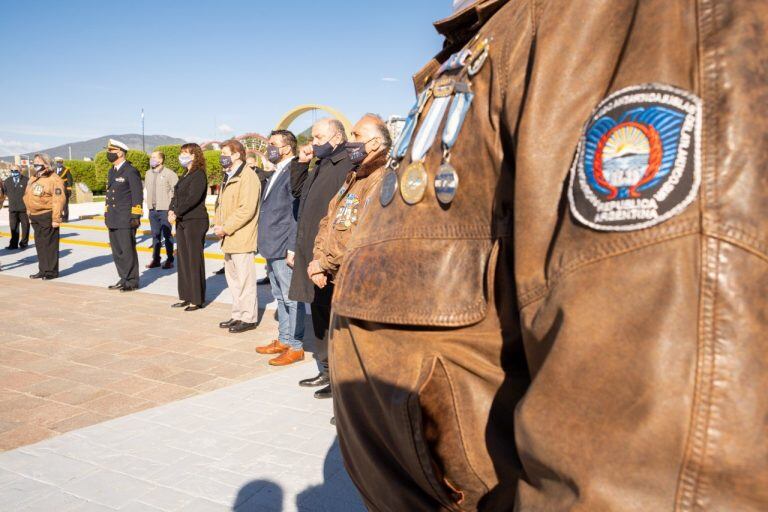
left=333, top=237, right=492, bottom=327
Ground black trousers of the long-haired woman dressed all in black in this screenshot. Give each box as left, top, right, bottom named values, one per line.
left=176, top=219, right=208, bottom=306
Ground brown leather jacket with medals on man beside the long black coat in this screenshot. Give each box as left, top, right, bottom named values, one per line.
left=314, top=163, right=384, bottom=276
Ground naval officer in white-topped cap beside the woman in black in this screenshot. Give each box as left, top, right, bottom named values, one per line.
left=104, top=139, right=144, bottom=292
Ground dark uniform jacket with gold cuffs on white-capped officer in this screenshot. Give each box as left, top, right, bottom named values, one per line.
left=104, top=161, right=144, bottom=229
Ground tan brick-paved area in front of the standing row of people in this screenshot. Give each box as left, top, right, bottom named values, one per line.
left=0, top=274, right=312, bottom=451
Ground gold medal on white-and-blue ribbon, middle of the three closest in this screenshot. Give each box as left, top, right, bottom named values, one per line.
left=400, top=92, right=451, bottom=205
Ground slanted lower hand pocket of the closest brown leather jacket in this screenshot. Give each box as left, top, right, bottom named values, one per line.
left=406, top=356, right=488, bottom=511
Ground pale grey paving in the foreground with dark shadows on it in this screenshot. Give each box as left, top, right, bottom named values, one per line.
left=0, top=363, right=364, bottom=512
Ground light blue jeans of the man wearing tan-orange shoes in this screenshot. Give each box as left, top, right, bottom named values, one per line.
left=267, top=258, right=306, bottom=350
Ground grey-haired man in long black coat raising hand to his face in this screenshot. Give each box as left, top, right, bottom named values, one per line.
left=288, top=118, right=355, bottom=398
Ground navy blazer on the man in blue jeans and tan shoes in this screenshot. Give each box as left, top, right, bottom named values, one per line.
left=256, top=159, right=299, bottom=259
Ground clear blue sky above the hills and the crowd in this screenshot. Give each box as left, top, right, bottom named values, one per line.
left=0, top=0, right=451, bottom=155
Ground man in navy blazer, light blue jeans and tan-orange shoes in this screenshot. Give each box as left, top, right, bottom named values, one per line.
left=256, top=130, right=305, bottom=366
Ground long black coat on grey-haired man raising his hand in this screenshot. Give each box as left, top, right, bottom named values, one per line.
left=288, top=144, right=355, bottom=305
